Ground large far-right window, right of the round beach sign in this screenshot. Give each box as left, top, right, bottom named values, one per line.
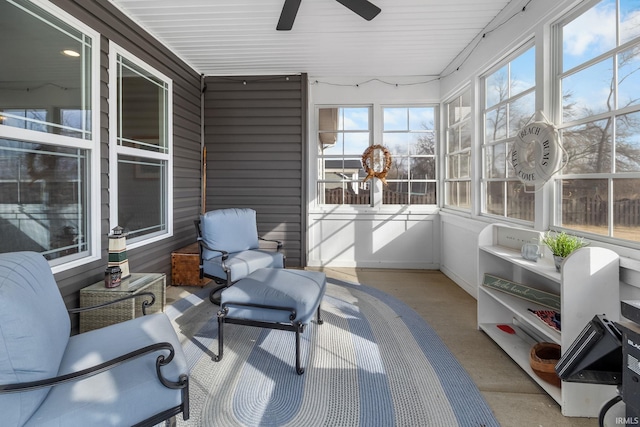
left=555, top=0, right=640, bottom=242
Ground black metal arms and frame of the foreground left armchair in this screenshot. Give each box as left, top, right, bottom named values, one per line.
left=0, top=292, right=189, bottom=427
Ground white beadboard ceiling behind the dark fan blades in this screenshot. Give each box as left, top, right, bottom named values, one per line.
left=110, top=0, right=517, bottom=76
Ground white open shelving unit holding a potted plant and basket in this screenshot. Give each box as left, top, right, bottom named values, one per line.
left=478, top=224, right=620, bottom=417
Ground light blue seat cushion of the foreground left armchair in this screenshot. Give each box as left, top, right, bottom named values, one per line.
left=25, top=313, right=187, bottom=427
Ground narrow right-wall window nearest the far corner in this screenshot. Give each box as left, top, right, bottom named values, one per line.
left=444, top=89, right=471, bottom=210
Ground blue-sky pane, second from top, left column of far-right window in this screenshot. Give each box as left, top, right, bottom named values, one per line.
left=561, top=59, right=613, bottom=122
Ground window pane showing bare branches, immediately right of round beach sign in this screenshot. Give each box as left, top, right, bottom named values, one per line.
left=562, top=119, right=612, bottom=174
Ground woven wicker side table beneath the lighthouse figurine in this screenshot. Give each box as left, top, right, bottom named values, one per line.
left=80, top=273, right=166, bottom=333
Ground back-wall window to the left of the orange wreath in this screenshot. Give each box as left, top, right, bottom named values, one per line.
left=317, top=107, right=372, bottom=205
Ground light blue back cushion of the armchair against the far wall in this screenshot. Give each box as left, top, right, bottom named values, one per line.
left=200, top=208, right=258, bottom=260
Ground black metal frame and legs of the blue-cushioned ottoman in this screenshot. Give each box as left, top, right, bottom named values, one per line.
left=213, top=302, right=324, bottom=375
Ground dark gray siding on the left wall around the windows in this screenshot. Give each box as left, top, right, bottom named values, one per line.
left=51, top=0, right=201, bottom=307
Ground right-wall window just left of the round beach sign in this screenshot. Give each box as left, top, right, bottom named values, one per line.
left=482, top=47, right=536, bottom=221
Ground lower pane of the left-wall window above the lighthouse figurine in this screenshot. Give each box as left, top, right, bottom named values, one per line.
left=118, top=156, right=167, bottom=239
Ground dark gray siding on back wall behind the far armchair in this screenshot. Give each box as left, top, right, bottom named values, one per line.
left=204, top=74, right=307, bottom=267
